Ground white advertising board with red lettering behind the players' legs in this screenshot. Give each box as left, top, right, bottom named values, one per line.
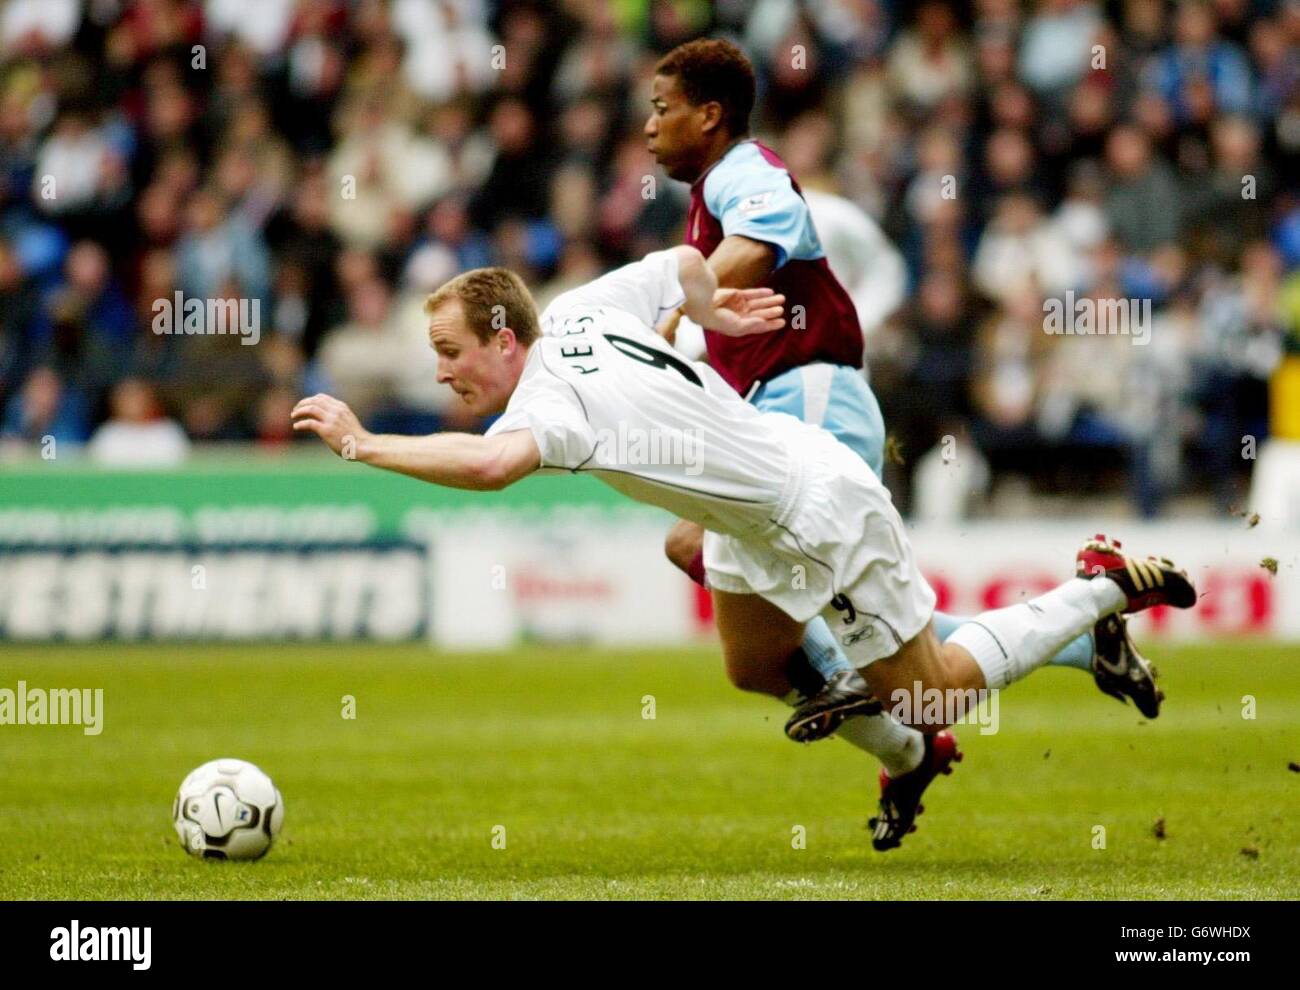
left=429, top=516, right=1300, bottom=650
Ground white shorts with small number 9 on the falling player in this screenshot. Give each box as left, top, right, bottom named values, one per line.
left=705, top=430, right=935, bottom=668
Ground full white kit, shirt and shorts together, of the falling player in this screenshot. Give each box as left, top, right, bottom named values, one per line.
left=488, top=252, right=935, bottom=654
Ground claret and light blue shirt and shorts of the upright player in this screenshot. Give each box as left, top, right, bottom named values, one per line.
left=686, top=140, right=884, bottom=476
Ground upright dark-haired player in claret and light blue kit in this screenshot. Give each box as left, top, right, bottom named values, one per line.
left=645, top=40, right=1161, bottom=850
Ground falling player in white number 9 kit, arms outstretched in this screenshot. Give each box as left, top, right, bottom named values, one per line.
left=293, top=247, right=1196, bottom=769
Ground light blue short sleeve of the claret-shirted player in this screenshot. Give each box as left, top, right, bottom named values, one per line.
left=705, top=162, right=813, bottom=268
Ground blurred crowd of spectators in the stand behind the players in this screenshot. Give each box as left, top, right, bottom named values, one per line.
left=0, top=0, right=1300, bottom=514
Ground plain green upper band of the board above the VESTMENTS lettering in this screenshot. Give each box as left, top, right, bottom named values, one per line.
left=0, top=451, right=628, bottom=547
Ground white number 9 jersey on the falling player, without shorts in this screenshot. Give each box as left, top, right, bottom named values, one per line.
left=488, top=251, right=816, bottom=537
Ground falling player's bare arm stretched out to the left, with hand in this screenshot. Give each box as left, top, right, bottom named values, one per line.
left=293, top=395, right=542, bottom=491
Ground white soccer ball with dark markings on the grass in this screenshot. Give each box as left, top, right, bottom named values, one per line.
left=172, top=760, right=285, bottom=859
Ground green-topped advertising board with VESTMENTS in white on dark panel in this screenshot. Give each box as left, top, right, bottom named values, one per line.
left=0, top=450, right=654, bottom=641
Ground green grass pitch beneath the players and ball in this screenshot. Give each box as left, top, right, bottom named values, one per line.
left=0, top=643, right=1300, bottom=899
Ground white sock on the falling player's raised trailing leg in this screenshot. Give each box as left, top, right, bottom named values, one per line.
left=946, top=577, right=1127, bottom=689
